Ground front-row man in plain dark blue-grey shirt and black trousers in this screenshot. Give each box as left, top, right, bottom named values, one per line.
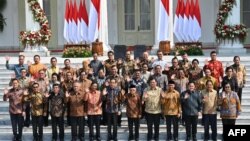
left=181, top=82, right=202, bottom=141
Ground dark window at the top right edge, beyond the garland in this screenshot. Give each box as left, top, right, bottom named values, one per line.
left=242, top=0, right=250, bottom=28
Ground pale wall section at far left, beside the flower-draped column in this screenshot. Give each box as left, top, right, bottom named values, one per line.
left=0, top=0, right=19, bottom=50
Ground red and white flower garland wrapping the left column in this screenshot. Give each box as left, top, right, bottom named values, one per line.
left=19, top=0, right=52, bottom=46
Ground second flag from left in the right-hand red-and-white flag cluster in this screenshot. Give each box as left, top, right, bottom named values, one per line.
left=183, top=0, right=190, bottom=42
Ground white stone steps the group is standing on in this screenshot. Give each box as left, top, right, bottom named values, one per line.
left=0, top=56, right=250, bottom=141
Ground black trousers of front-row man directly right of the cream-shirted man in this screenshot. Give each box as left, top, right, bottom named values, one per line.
left=165, top=115, right=178, bottom=140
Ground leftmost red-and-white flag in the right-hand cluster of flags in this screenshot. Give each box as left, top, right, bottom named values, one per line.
left=174, top=0, right=182, bottom=41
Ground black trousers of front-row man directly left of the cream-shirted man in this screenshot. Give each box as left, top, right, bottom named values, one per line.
left=128, top=117, right=140, bottom=139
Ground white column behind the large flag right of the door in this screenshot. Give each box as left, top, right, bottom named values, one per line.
left=151, top=0, right=174, bottom=54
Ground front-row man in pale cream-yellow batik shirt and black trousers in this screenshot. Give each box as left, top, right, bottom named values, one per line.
left=142, top=78, right=162, bottom=141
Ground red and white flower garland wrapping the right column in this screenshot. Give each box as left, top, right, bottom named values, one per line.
left=214, top=0, right=247, bottom=42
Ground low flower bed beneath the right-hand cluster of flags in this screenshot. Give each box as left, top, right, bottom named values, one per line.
left=172, top=43, right=204, bottom=56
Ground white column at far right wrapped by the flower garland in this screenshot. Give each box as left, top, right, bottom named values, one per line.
left=218, top=0, right=246, bottom=55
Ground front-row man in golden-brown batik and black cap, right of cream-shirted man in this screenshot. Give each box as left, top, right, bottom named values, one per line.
left=161, top=80, right=182, bottom=141
